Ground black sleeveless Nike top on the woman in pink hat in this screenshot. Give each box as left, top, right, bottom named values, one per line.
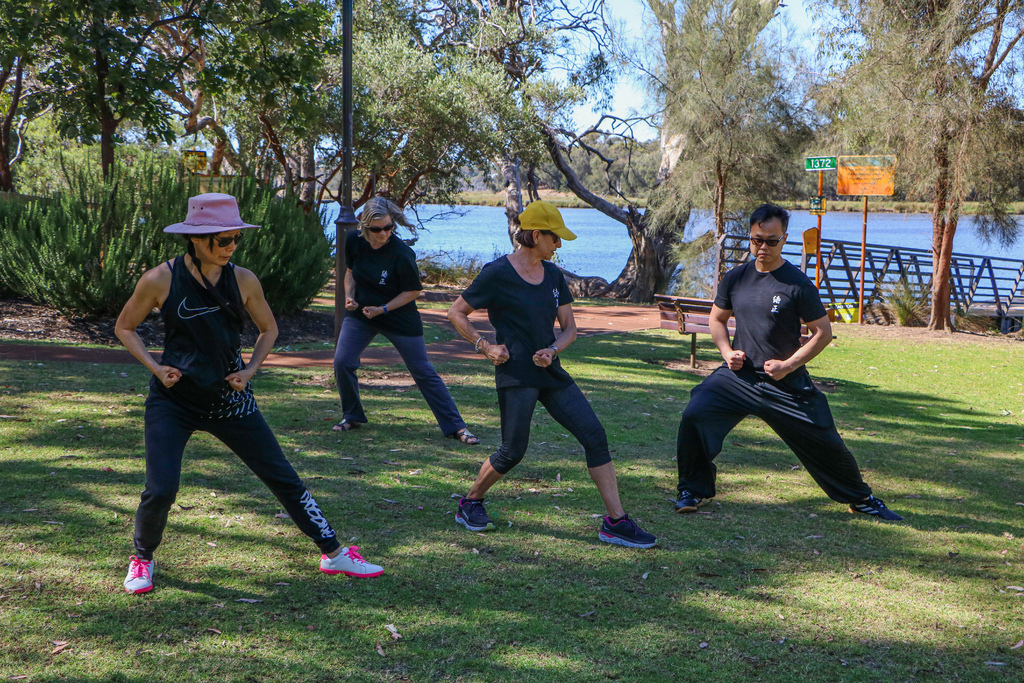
left=150, top=256, right=259, bottom=419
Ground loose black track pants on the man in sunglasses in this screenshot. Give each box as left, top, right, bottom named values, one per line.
left=676, top=366, right=871, bottom=503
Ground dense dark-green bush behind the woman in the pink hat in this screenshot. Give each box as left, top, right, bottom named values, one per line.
left=0, top=163, right=331, bottom=316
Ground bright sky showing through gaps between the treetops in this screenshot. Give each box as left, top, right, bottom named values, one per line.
left=572, top=0, right=814, bottom=140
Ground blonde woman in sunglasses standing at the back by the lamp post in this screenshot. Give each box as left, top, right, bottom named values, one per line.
left=334, top=197, right=480, bottom=445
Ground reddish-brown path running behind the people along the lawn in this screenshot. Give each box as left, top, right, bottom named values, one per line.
left=0, top=306, right=658, bottom=368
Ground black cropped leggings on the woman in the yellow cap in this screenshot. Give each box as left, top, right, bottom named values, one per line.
left=490, top=382, right=611, bottom=474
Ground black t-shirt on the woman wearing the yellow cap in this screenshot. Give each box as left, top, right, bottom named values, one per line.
left=462, top=256, right=572, bottom=389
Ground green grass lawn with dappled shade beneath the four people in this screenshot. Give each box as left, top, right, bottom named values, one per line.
left=0, top=328, right=1024, bottom=683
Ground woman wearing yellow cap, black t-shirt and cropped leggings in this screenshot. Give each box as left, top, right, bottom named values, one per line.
left=447, top=202, right=656, bottom=548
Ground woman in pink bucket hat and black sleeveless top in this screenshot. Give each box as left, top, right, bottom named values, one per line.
left=115, top=193, right=383, bottom=593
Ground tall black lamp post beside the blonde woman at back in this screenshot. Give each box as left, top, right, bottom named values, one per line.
left=334, top=0, right=358, bottom=340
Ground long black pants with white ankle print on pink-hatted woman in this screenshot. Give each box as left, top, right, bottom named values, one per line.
left=135, top=393, right=341, bottom=560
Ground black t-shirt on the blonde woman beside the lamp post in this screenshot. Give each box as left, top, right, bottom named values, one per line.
left=345, top=230, right=423, bottom=337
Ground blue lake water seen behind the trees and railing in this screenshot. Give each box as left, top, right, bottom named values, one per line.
left=325, top=204, right=1024, bottom=282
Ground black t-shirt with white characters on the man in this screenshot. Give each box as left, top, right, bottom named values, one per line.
left=715, top=261, right=825, bottom=373
